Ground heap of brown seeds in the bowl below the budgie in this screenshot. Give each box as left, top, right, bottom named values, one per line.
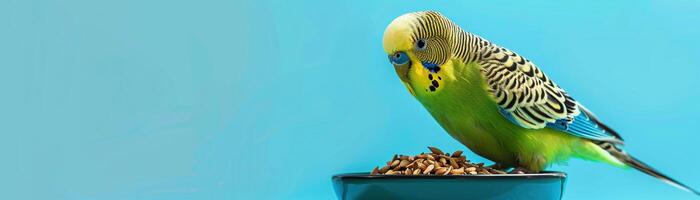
left=371, top=147, right=506, bottom=175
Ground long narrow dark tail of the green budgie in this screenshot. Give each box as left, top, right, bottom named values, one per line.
left=598, top=142, right=700, bottom=196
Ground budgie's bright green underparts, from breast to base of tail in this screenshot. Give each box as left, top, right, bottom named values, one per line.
left=404, top=60, right=611, bottom=171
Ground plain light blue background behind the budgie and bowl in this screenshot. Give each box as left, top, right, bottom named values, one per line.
left=5, top=0, right=700, bottom=199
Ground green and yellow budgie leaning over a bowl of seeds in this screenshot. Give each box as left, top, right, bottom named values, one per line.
left=382, top=11, right=700, bottom=195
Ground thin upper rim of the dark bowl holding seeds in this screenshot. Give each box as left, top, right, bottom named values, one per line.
left=333, top=171, right=566, bottom=179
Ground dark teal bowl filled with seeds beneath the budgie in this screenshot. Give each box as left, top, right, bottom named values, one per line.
left=333, top=172, right=566, bottom=200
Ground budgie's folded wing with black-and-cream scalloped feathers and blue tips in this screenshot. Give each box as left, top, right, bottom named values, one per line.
left=479, top=46, right=622, bottom=143
